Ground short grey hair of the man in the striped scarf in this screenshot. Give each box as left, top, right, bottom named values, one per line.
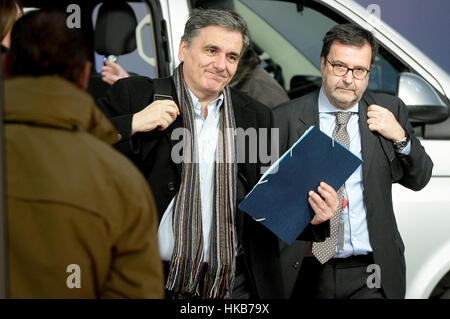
left=181, top=9, right=250, bottom=54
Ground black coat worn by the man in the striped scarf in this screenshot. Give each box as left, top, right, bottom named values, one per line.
left=98, top=77, right=329, bottom=298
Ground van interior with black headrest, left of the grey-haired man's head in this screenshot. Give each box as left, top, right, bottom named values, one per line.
left=22, top=0, right=169, bottom=99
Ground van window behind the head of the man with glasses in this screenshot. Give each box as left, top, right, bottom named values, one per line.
left=197, top=0, right=407, bottom=98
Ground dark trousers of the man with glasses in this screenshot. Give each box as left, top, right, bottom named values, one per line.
left=291, top=254, right=386, bottom=299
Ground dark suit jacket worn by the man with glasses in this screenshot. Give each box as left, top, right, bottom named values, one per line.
left=273, top=90, right=433, bottom=298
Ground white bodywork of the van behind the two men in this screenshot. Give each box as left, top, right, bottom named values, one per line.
left=161, top=0, right=450, bottom=298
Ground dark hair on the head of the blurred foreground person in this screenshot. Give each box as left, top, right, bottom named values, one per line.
left=9, top=9, right=91, bottom=83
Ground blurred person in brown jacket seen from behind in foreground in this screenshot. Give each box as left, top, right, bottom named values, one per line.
left=4, top=10, right=163, bottom=298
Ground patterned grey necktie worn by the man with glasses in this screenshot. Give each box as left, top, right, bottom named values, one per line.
left=312, top=112, right=352, bottom=264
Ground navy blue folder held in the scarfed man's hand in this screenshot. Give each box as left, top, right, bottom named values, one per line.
left=238, top=126, right=362, bottom=245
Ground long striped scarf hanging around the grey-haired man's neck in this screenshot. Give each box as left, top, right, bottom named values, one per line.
left=166, top=63, right=237, bottom=298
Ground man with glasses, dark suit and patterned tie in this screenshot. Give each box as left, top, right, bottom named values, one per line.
left=274, top=24, right=433, bottom=299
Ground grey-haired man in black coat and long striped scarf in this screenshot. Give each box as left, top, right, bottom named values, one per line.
left=99, top=9, right=337, bottom=298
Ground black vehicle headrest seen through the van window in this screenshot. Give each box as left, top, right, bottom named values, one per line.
left=95, top=1, right=137, bottom=56
